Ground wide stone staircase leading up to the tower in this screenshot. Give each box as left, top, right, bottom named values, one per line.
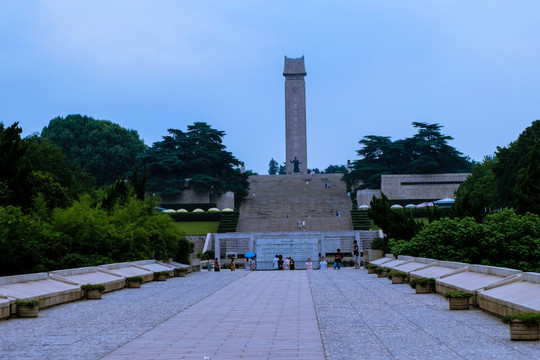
left=238, top=174, right=352, bottom=232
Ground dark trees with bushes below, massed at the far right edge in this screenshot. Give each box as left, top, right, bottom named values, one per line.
left=378, top=120, right=540, bottom=272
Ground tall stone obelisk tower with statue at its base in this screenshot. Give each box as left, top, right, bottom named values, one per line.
left=283, top=56, right=307, bottom=175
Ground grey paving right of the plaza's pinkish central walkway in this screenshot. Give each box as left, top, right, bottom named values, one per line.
left=309, top=269, right=540, bottom=360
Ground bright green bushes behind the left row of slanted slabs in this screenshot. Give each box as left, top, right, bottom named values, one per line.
left=0, top=193, right=193, bottom=276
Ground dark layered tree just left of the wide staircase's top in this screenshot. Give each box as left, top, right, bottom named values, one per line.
left=139, top=122, right=249, bottom=199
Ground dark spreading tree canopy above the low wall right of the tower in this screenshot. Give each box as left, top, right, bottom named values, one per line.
left=343, top=122, right=472, bottom=189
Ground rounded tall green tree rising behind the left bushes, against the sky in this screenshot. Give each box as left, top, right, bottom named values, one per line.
left=41, top=115, right=146, bottom=186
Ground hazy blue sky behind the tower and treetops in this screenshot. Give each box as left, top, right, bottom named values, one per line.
left=0, top=0, right=540, bottom=174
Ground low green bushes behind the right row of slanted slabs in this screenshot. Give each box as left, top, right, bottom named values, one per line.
left=388, top=210, right=540, bottom=272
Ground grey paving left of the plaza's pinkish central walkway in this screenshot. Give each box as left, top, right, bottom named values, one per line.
left=0, top=271, right=249, bottom=360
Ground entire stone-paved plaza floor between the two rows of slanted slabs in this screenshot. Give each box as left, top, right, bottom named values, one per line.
left=0, top=268, right=540, bottom=360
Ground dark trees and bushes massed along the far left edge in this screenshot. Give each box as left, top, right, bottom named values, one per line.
left=0, top=118, right=208, bottom=276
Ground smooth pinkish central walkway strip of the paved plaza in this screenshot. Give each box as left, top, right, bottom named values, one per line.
left=104, top=271, right=324, bottom=360
